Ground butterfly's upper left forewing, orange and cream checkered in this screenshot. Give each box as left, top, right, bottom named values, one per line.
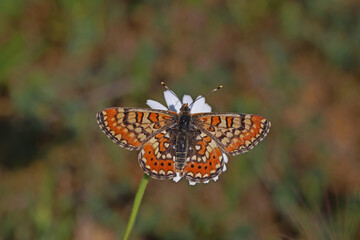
left=96, top=107, right=177, bottom=150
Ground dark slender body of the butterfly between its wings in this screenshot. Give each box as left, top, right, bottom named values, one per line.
left=175, top=104, right=191, bottom=171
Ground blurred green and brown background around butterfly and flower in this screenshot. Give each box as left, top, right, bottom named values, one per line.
left=0, top=0, right=360, bottom=240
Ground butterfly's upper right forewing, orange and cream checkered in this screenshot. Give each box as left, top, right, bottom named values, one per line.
left=193, top=113, right=271, bottom=155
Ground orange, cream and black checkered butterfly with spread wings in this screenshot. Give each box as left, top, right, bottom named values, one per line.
left=96, top=84, right=271, bottom=183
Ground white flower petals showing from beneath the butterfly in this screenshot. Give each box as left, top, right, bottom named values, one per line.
left=146, top=90, right=228, bottom=185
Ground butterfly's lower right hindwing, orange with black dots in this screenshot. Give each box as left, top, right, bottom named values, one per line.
left=184, top=132, right=224, bottom=182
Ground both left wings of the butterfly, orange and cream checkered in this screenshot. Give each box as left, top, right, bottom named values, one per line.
left=97, top=108, right=178, bottom=180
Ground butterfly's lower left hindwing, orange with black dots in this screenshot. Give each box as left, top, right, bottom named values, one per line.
left=138, top=130, right=176, bottom=180
